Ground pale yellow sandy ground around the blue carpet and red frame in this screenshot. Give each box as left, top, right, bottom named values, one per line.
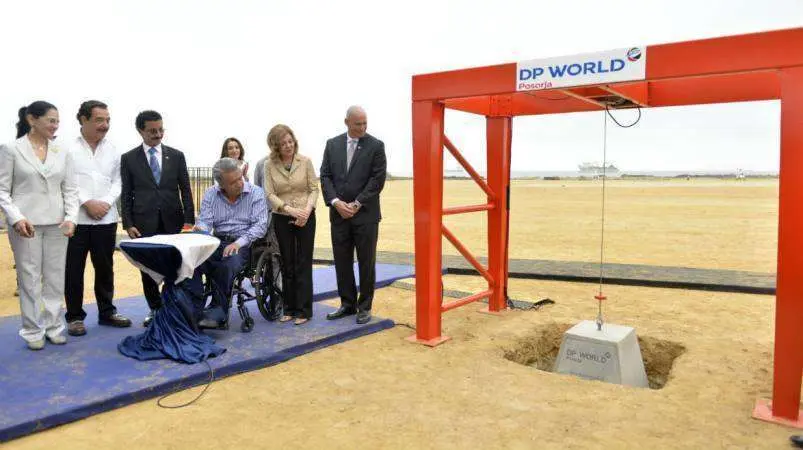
left=0, top=180, right=793, bottom=449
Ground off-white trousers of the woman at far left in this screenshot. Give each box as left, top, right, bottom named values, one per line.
left=8, top=225, right=67, bottom=342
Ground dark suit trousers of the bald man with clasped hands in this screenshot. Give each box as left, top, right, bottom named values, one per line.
left=332, top=220, right=379, bottom=311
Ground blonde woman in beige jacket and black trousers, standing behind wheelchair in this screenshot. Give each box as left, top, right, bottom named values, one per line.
left=264, top=125, right=318, bottom=325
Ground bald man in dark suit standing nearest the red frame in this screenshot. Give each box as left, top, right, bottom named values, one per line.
left=321, top=106, right=387, bottom=324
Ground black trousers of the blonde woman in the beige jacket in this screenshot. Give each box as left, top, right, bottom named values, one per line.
left=271, top=210, right=315, bottom=319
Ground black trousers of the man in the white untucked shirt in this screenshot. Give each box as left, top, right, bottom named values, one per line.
left=64, top=223, right=117, bottom=322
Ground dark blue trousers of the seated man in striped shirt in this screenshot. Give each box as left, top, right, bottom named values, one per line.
left=191, top=240, right=251, bottom=322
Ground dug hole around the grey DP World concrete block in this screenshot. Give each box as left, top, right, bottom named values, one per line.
left=505, top=323, right=686, bottom=389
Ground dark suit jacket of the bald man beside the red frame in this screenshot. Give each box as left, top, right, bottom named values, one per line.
left=321, top=133, right=387, bottom=224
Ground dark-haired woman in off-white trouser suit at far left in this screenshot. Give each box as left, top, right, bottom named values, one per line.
left=0, top=101, right=78, bottom=350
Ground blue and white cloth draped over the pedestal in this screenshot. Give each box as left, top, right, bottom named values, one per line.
left=117, top=235, right=226, bottom=364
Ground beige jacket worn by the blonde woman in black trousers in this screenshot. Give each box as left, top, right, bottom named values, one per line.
left=264, top=153, right=318, bottom=215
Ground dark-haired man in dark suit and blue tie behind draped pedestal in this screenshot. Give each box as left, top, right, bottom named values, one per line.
left=120, top=111, right=195, bottom=326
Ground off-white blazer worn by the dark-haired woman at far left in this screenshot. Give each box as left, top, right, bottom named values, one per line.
left=0, top=136, right=79, bottom=225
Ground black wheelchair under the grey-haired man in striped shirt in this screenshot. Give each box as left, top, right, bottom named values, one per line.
left=204, top=222, right=284, bottom=333
